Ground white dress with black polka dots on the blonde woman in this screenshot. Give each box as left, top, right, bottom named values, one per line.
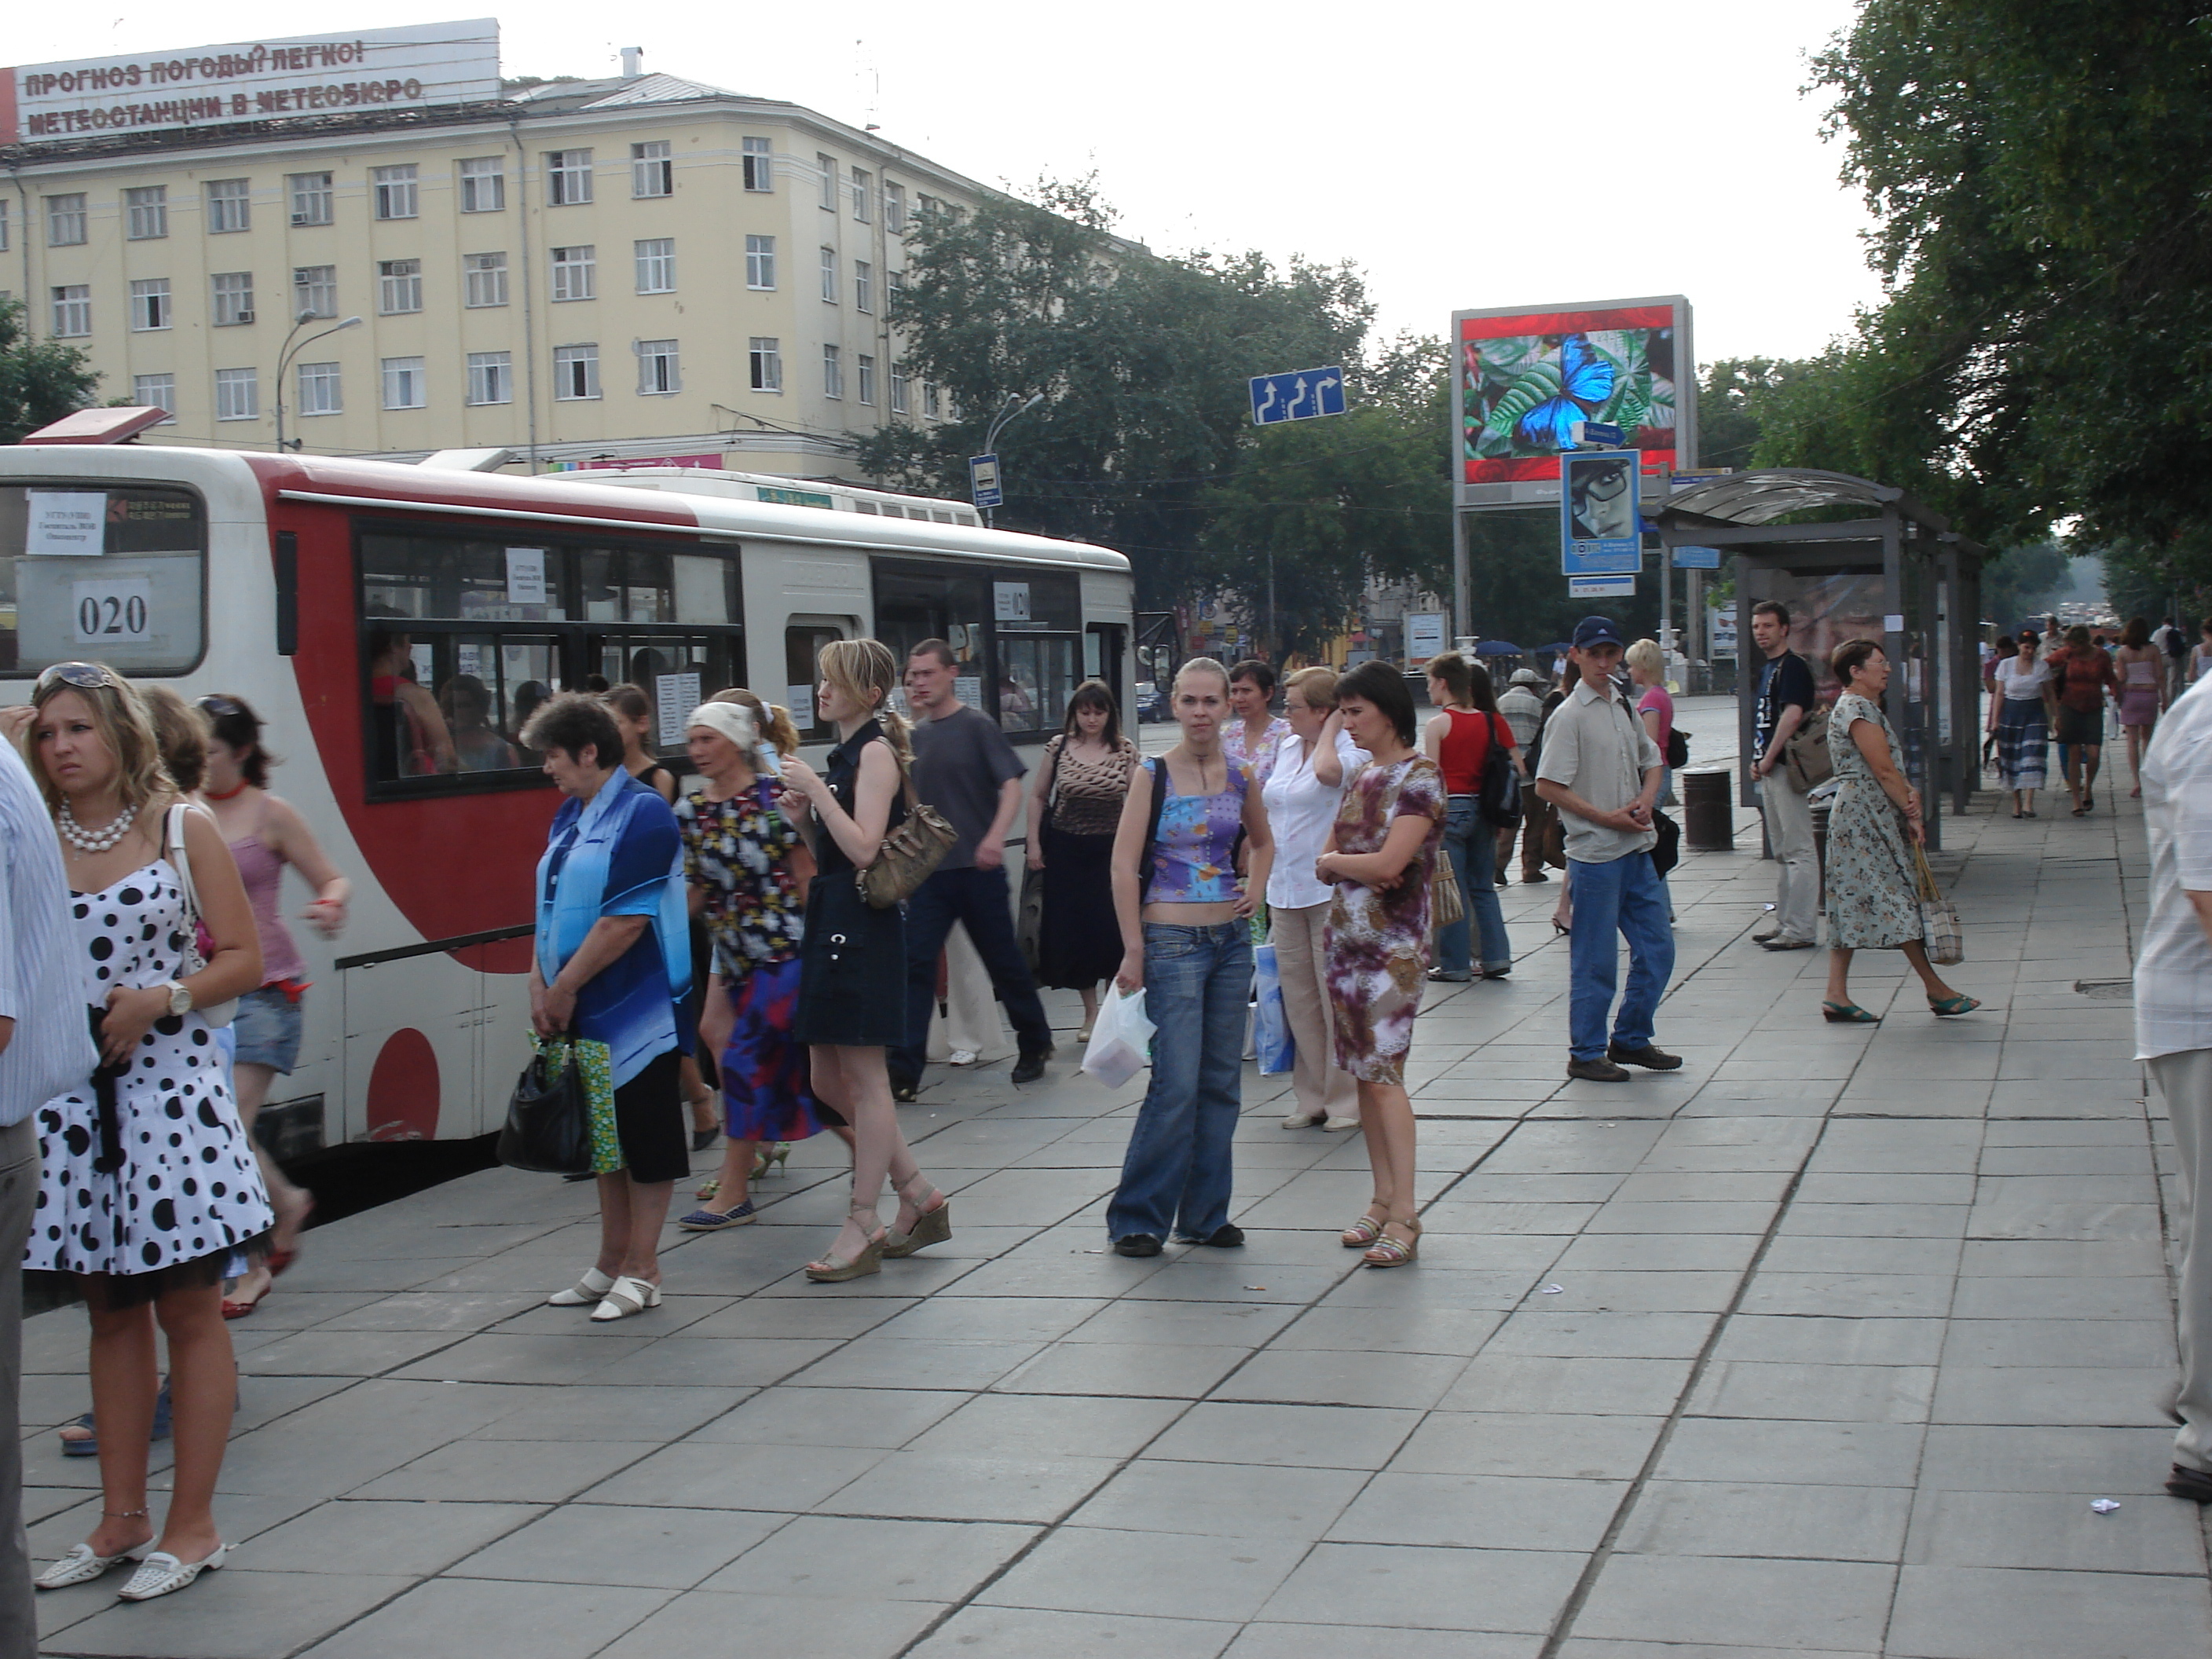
left=22, top=862, right=276, bottom=1292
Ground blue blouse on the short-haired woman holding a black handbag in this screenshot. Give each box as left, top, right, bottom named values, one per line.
left=537, top=767, right=690, bottom=1088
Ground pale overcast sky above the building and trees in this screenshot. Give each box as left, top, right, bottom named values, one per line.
left=17, top=0, right=1878, bottom=367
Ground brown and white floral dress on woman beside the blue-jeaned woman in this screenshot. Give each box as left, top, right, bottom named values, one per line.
left=1325, top=754, right=1445, bottom=1084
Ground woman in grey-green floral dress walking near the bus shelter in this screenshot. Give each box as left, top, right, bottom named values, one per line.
left=1821, top=639, right=1982, bottom=1024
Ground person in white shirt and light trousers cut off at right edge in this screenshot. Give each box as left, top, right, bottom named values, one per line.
left=2134, top=668, right=2212, bottom=1504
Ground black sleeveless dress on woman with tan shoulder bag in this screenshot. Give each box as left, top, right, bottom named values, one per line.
left=792, top=721, right=907, bottom=1049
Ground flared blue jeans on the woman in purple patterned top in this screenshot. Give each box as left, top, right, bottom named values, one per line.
left=1106, top=920, right=1252, bottom=1239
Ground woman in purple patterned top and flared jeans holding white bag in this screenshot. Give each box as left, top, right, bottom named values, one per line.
left=1106, top=657, right=1274, bottom=1256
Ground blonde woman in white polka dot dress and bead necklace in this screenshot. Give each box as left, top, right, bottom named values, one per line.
left=22, top=664, right=276, bottom=1602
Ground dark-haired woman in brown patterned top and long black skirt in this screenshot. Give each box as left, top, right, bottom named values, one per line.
left=1028, top=679, right=1137, bottom=1042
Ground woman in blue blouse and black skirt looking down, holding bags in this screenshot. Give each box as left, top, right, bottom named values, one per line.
left=522, top=692, right=690, bottom=1320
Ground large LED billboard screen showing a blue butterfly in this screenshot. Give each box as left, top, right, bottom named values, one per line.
left=1451, top=295, right=1697, bottom=507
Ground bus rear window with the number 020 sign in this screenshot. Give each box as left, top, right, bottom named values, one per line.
left=0, top=482, right=208, bottom=675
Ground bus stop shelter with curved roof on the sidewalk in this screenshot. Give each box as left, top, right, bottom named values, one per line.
left=1653, top=467, right=1984, bottom=848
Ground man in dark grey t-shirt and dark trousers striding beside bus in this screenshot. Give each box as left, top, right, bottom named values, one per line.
left=889, top=639, right=1053, bottom=1101
